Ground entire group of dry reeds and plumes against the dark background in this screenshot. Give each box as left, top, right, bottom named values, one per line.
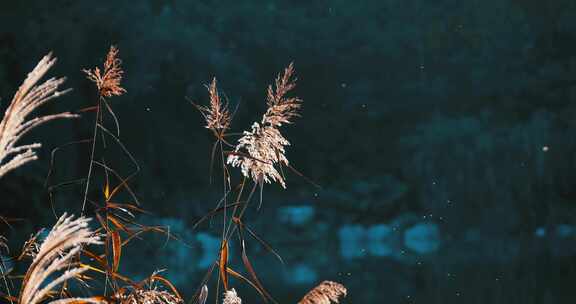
left=0, top=46, right=346, bottom=304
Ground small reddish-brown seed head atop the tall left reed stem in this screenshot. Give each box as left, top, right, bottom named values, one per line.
left=82, top=46, right=126, bottom=97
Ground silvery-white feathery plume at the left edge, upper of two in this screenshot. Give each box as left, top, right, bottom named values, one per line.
left=0, top=54, right=77, bottom=177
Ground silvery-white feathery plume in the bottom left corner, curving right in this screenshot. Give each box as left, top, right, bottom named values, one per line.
left=18, top=214, right=102, bottom=304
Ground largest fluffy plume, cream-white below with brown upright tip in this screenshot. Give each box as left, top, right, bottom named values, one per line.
left=227, top=64, right=302, bottom=188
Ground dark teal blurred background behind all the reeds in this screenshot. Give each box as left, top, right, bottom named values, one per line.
left=0, top=0, right=576, bottom=304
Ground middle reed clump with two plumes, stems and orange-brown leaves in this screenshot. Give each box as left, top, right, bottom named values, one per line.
left=190, top=64, right=302, bottom=304
